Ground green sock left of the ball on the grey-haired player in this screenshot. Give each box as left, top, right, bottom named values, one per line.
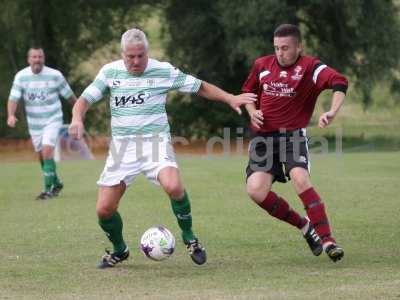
left=99, top=212, right=126, bottom=252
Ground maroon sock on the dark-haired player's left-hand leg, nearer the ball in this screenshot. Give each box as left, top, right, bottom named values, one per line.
left=258, top=192, right=307, bottom=229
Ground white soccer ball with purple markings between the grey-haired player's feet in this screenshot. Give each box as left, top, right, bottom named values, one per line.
left=140, top=226, right=175, bottom=261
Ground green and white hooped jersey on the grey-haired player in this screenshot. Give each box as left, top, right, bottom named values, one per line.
left=82, top=58, right=201, bottom=137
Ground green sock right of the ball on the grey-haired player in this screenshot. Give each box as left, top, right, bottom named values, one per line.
left=171, top=191, right=196, bottom=242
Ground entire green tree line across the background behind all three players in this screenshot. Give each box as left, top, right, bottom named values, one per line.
left=0, top=0, right=400, bottom=138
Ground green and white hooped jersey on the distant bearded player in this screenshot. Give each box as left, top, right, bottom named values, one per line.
left=9, top=66, right=73, bottom=135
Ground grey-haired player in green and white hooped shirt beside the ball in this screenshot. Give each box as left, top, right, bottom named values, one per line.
left=69, top=28, right=256, bottom=268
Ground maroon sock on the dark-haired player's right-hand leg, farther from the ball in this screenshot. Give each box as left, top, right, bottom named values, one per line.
left=299, top=187, right=335, bottom=243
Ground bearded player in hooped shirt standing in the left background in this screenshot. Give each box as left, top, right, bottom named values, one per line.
left=7, top=47, right=76, bottom=200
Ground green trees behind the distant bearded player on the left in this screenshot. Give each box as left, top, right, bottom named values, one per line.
left=0, top=0, right=159, bottom=136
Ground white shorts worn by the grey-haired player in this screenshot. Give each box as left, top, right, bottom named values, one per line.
left=97, top=135, right=178, bottom=186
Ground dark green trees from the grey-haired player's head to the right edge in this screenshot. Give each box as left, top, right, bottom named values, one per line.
left=165, top=0, right=400, bottom=136
